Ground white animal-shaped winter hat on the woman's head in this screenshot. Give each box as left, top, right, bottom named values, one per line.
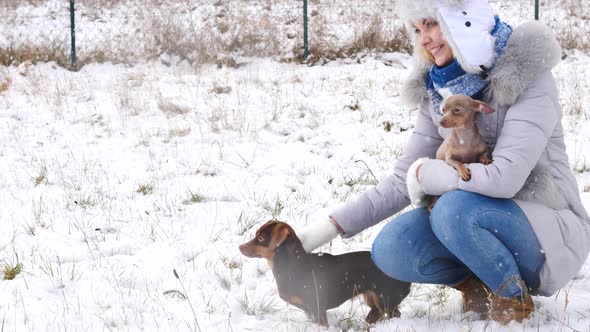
left=398, top=0, right=495, bottom=73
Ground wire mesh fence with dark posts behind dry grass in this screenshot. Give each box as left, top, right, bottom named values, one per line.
left=0, top=0, right=590, bottom=67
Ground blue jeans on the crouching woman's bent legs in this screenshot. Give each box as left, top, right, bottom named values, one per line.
left=372, top=190, right=545, bottom=297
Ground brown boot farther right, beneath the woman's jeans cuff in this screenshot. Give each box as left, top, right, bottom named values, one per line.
left=489, top=292, right=535, bottom=325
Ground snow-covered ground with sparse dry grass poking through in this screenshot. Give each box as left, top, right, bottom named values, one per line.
left=0, top=0, right=590, bottom=331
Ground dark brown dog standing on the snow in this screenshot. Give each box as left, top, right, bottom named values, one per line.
left=240, top=220, right=410, bottom=326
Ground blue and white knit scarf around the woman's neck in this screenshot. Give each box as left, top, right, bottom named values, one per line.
left=426, top=16, right=512, bottom=112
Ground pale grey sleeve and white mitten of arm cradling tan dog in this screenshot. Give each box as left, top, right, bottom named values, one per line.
left=420, top=72, right=561, bottom=198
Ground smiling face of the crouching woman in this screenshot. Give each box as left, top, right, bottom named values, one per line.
left=412, top=19, right=453, bottom=67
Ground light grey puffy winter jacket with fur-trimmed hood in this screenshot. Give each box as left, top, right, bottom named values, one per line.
left=331, top=22, right=590, bottom=296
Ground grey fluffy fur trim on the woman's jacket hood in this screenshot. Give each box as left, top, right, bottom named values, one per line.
left=401, top=21, right=561, bottom=106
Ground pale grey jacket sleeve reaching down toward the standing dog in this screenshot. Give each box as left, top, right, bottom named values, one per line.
left=330, top=102, right=442, bottom=238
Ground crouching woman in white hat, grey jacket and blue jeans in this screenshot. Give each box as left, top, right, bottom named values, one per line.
left=300, top=0, right=590, bottom=324
